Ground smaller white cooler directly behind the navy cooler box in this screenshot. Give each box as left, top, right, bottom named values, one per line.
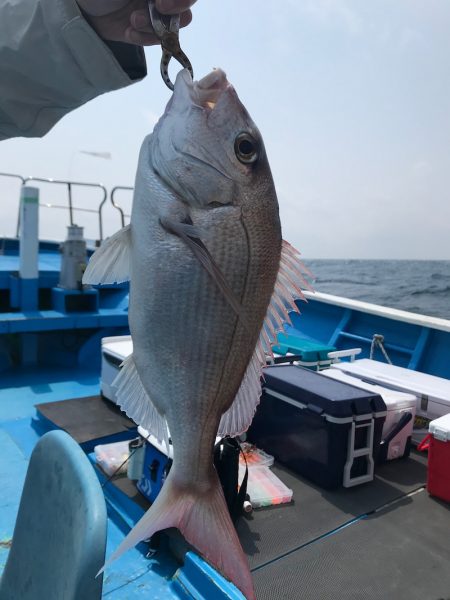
left=321, top=369, right=417, bottom=460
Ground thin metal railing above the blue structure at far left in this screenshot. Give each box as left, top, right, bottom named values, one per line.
left=0, top=172, right=134, bottom=242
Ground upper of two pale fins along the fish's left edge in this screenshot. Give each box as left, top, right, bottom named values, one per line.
left=83, top=225, right=131, bottom=285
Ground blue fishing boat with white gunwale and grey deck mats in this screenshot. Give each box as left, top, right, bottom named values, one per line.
left=0, top=174, right=450, bottom=600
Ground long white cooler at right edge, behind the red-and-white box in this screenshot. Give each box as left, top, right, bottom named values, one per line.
left=332, top=358, right=450, bottom=444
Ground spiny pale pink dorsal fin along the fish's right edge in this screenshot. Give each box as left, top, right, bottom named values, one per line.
left=218, top=240, right=312, bottom=436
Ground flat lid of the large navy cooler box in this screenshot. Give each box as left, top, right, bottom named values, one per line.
left=263, top=365, right=386, bottom=418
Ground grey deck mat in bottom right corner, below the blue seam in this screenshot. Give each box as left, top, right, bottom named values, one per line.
left=253, top=491, right=450, bottom=600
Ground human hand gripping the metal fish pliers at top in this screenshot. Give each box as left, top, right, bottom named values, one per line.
left=77, top=0, right=196, bottom=46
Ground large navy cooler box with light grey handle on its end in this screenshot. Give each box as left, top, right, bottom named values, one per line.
left=248, top=365, right=386, bottom=489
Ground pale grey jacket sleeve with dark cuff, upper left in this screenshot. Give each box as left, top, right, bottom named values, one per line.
left=0, top=0, right=145, bottom=140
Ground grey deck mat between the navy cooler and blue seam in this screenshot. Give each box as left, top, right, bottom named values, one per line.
left=237, top=451, right=428, bottom=568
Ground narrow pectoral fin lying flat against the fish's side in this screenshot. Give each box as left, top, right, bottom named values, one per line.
left=160, top=218, right=248, bottom=329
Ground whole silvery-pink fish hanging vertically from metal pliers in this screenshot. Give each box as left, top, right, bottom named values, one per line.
left=83, top=69, right=305, bottom=600
